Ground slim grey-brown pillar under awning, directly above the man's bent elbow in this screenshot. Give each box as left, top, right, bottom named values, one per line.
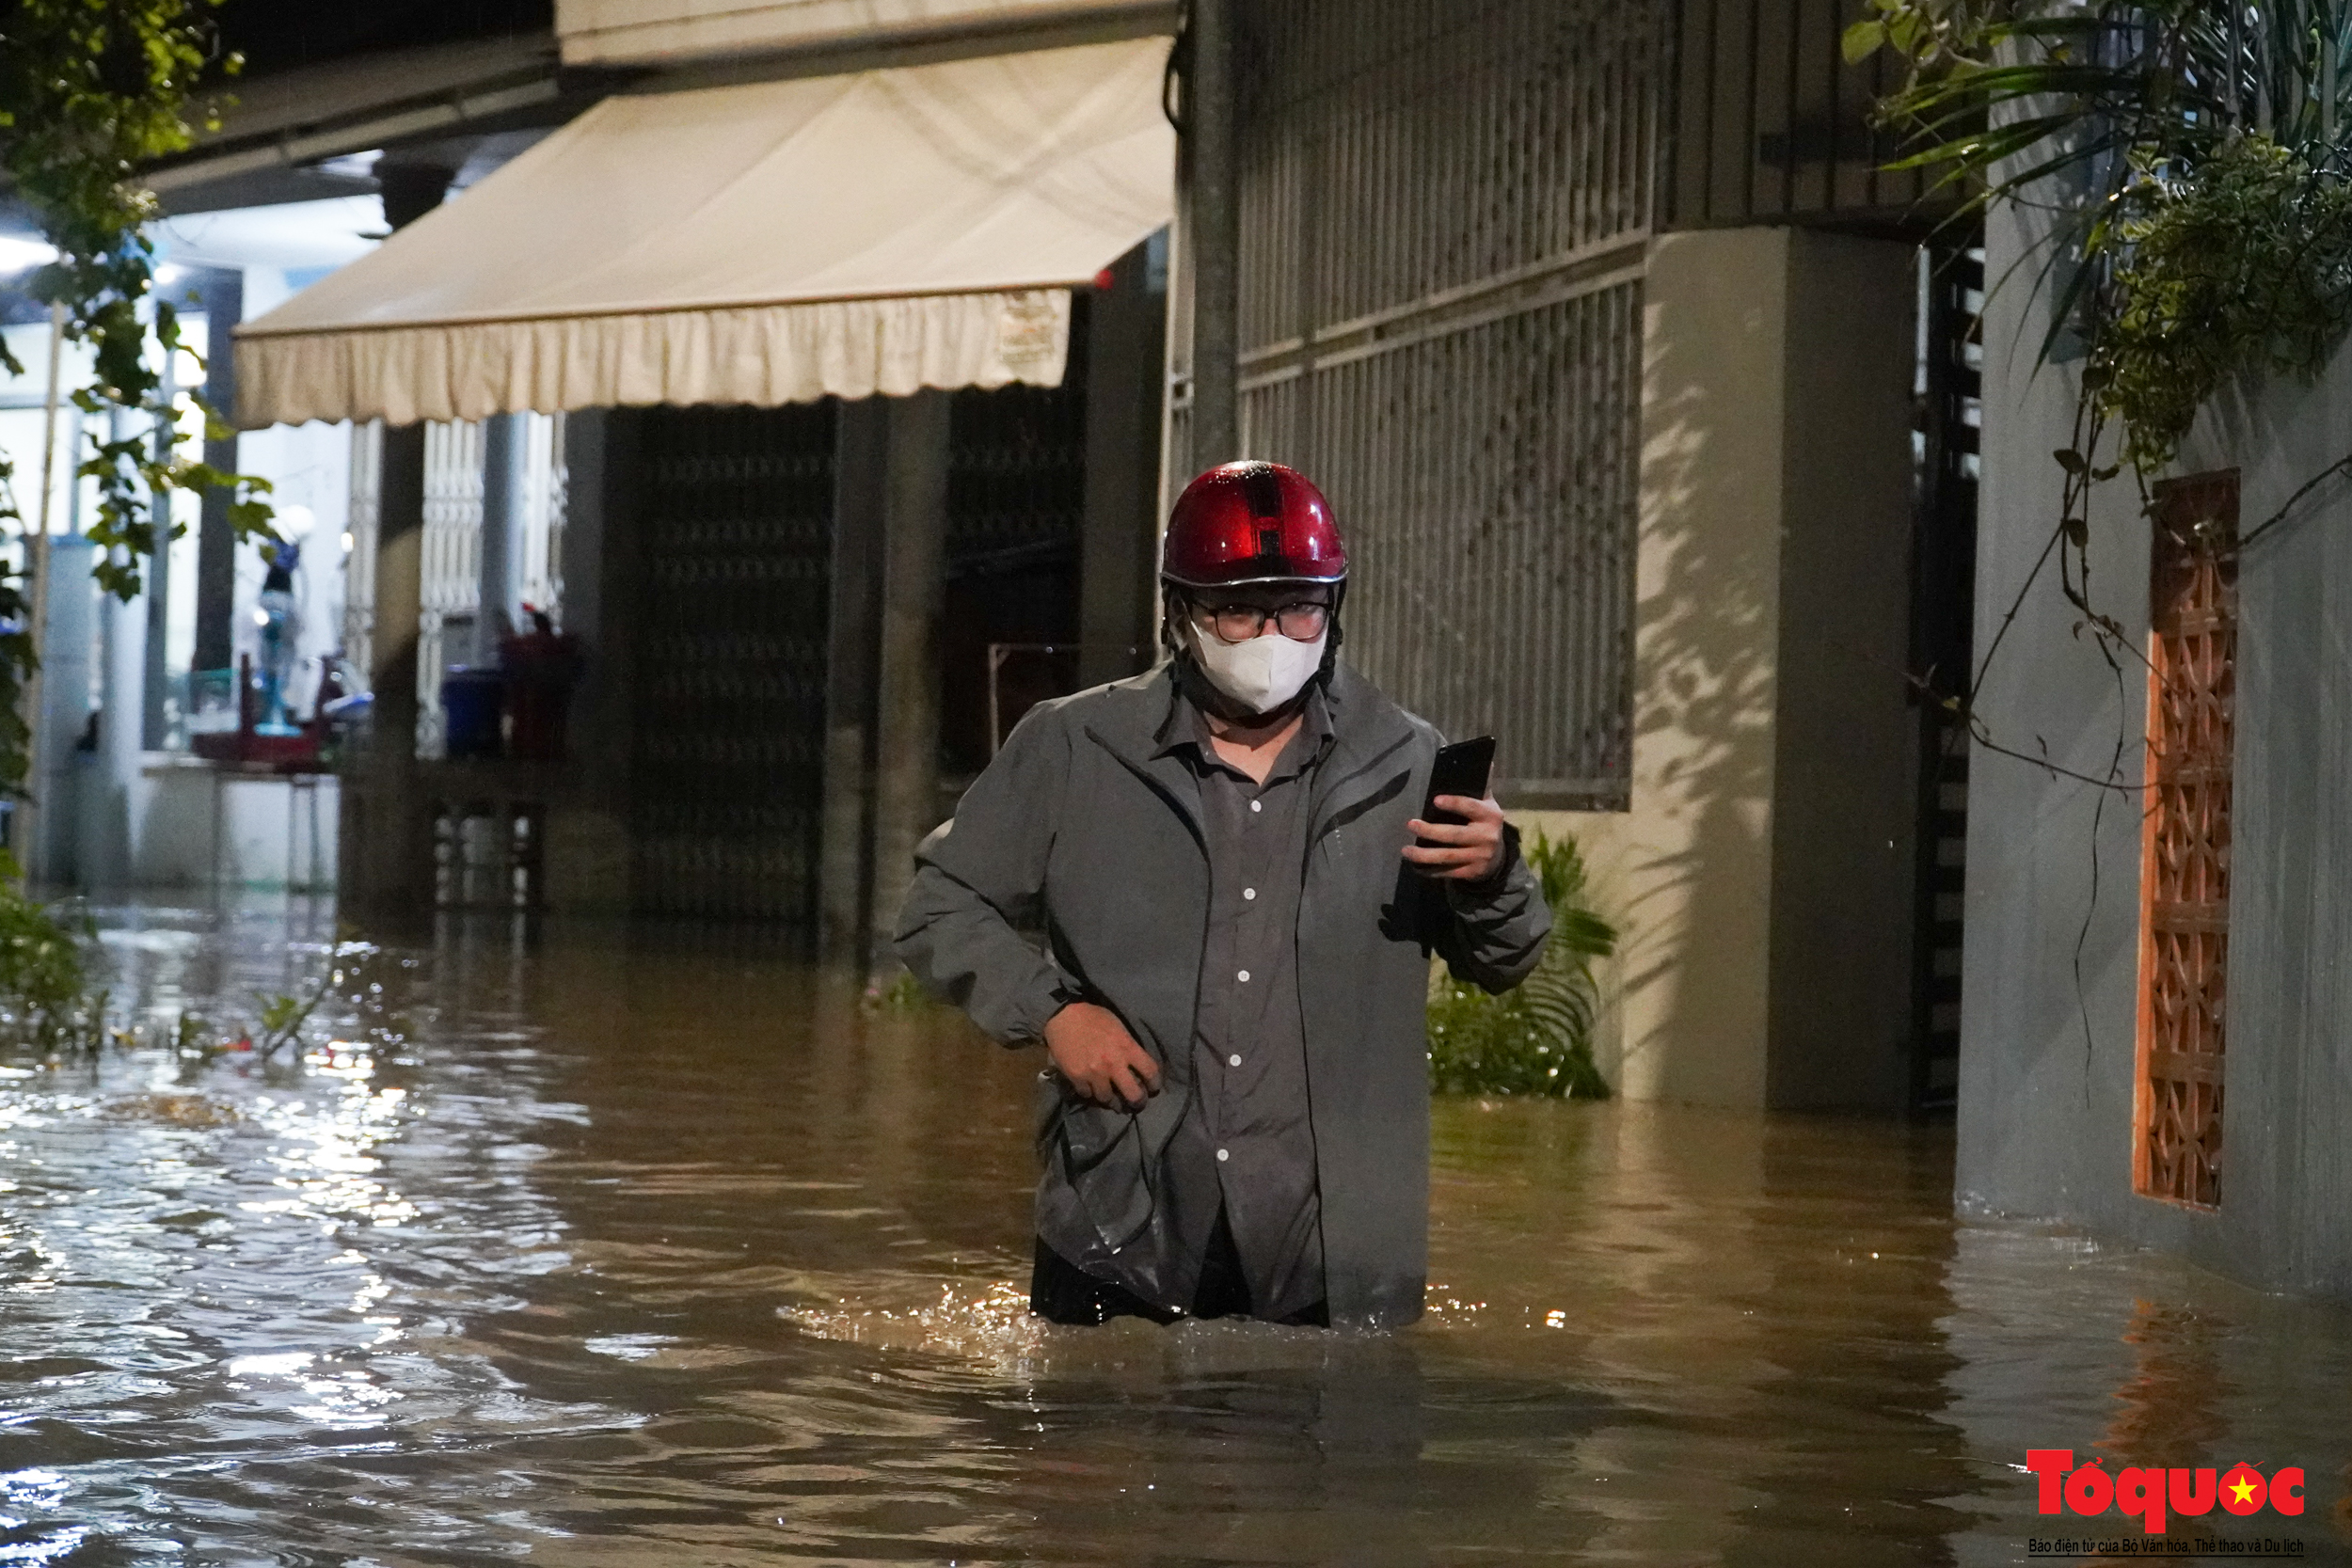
left=870, top=390, right=948, bottom=959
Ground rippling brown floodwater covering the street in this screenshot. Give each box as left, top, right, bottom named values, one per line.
left=0, top=903, right=2352, bottom=1568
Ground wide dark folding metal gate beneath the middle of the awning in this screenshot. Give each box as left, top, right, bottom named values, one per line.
left=630, top=402, right=835, bottom=924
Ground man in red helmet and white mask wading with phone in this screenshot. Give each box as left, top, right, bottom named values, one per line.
left=898, top=463, right=1550, bottom=1326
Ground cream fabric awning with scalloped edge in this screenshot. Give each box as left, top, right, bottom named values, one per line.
left=235, top=38, right=1176, bottom=428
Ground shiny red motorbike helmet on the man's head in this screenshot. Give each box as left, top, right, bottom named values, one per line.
left=1160, top=461, right=1348, bottom=588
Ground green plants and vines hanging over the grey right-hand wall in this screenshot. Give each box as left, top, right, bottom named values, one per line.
left=1844, top=0, right=2352, bottom=737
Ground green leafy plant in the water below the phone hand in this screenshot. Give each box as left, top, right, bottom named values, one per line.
left=1428, top=830, right=1616, bottom=1101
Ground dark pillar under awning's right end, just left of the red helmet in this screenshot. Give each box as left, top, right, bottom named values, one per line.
left=1077, top=240, right=1167, bottom=687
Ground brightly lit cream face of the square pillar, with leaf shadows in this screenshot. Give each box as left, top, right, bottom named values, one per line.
left=1538, top=228, right=1788, bottom=1105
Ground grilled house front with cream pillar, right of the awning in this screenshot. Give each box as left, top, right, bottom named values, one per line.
left=1169, top=0, right=1974, bottom=1110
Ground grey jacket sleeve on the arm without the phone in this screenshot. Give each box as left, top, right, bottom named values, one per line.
left=894, top=707, right=1073, bottom=1046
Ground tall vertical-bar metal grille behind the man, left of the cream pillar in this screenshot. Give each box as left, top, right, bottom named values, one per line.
left=1214, top=0, right=1665, bottom=806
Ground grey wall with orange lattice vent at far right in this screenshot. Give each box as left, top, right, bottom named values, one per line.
left=1960, top=192, right=2352, bottom=1295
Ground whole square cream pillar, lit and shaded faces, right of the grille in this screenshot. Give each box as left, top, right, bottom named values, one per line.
left=1538, top=228, right=1917, bottom=1110
